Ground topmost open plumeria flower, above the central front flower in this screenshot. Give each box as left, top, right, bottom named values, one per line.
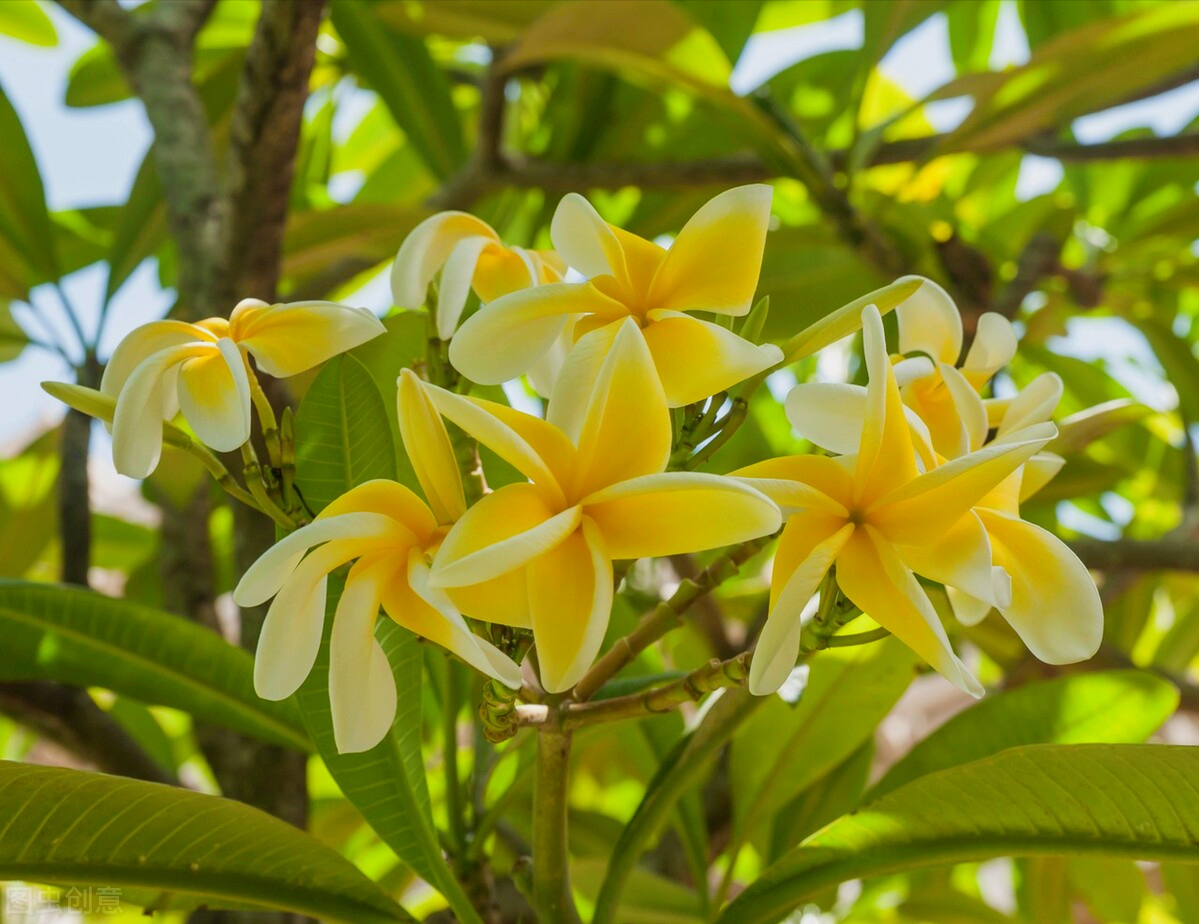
left=450, top=185, right=783, bottom=407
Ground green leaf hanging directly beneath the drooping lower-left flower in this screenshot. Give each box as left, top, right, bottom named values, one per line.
left=296, top=576, right=480, bottom=924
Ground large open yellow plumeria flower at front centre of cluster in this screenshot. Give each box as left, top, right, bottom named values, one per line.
left=422, top=320, right=779, bottom=693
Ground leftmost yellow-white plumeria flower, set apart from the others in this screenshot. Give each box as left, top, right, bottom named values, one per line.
left=100, top=298, right=384, bottom=478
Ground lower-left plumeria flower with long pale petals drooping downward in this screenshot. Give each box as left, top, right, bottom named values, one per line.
left=234, top=474, right=520, bottom=754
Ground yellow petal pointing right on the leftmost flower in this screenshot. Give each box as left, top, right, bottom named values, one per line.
left=229, top=302, right=385, bottom=379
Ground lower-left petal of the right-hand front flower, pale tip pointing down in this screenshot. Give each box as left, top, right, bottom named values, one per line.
left=749, top=514, right=854, bottom=696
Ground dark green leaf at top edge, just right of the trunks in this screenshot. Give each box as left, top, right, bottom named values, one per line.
left=330, top=0, right=466, bottom=180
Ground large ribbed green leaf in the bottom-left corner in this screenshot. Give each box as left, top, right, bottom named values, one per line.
left=0, top=761, right=414, bottom=924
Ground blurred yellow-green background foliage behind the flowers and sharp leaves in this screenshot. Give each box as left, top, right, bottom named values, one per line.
left=0, top=0, right=1199, bottom=924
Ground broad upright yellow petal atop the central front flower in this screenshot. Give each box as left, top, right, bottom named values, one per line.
left=572, top=320, right=671, bottom=497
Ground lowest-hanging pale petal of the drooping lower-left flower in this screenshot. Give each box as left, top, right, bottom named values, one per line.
left=329, top=557, right=396, bottom=754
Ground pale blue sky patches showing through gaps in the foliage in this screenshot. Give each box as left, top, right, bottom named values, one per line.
left=0, top=2, right=1199, bottom=467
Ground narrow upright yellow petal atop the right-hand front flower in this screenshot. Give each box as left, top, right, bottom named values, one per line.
left=854, top=304, right=917, bottom=505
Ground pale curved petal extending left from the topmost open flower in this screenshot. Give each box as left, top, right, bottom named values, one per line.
left=450, top=283, right=628, bottom=385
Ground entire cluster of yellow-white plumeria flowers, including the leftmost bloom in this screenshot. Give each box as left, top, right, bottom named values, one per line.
left=70, top=186, right=1102, bottom=750
